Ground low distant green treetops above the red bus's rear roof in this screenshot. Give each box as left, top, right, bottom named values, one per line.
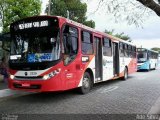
left=104, top=29, right=132, bottom=42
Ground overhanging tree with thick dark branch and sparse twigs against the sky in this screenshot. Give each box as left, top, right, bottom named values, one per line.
left=85, top=0, right=160, bottom=26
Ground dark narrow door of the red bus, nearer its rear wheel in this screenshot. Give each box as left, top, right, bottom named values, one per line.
left=113, top=42, right=119, bottom=77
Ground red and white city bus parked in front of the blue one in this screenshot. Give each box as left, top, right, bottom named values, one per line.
left=9, top=16, right=137, bottom=94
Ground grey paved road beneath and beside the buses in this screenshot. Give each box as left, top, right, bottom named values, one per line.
left=0, top=69, right=160, bottom=120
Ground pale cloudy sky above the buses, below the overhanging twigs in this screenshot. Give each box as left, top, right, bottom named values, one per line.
left=83, top=0, right=160, bottom=49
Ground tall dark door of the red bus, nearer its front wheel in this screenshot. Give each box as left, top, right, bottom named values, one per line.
left=94, top=37, right=103, bottom=82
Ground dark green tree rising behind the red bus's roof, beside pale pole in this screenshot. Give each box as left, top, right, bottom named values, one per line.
left=46, top=0, right=95, bottom=28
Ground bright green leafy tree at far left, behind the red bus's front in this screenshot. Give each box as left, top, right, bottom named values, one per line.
left=0, top=0, right=41, bottom=32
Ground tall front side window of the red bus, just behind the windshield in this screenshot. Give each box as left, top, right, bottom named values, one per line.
left=63, top=25, right=78, bottom=65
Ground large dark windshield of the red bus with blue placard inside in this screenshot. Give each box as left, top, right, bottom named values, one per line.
left=10, top=19, right=60, bottom=63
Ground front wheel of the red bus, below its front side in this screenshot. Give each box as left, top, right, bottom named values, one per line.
left=79, top=72, right=92, bottom=94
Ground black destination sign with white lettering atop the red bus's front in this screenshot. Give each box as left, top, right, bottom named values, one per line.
left=10, top=16, right=59, bottom=32
